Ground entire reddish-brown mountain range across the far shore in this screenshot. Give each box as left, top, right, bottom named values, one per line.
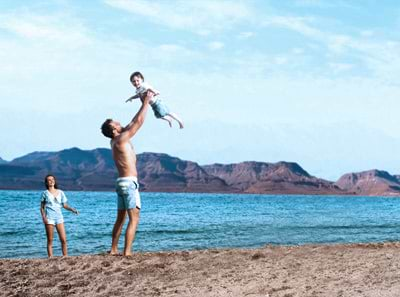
left=0, top=148, right=400, bottom=196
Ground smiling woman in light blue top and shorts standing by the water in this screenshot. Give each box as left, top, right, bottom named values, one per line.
left=40, top=174, right=79, bottom=258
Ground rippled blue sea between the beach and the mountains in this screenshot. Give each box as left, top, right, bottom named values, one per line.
left=0, top=191, right=400, bottom=258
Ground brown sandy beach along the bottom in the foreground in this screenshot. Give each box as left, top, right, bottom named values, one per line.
left=0, top=243, right=400, bottom=297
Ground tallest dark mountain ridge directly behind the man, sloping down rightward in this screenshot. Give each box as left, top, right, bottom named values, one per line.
left=0, top=148, right=231, bottom=192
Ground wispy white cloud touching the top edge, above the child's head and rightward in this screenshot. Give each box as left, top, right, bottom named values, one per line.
left=104, top=0, right=252, bottom=35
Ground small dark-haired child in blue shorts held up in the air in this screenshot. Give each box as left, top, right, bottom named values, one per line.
left=126, top=72, right=183, bottom=129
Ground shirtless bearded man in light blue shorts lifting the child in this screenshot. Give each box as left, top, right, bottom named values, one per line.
left=101, top=92, right=154, bottom=256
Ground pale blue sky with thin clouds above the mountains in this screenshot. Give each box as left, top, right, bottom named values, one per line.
left=0, top=0, right=400, bottom=180
